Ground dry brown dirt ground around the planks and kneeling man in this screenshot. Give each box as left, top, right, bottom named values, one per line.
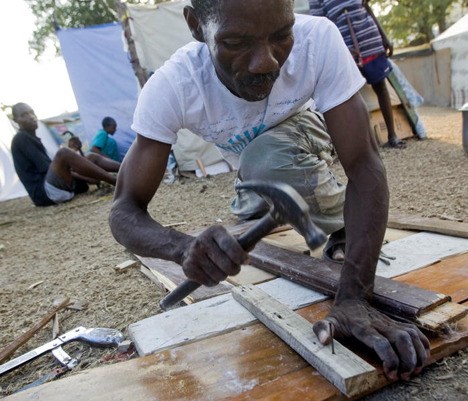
left=0, top=107, right=468, bottom=401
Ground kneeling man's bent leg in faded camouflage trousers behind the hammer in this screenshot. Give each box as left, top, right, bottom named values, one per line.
left=231, top=111, right=345, bottom=260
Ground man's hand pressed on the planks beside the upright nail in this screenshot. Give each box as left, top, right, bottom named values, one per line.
left=314, top=300, right=430, bottom=380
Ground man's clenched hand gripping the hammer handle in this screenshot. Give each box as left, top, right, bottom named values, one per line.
left=182, top=226, right=247, bottom=287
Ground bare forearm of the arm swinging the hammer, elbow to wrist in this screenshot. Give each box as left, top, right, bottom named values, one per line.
left=109, top=198, right=193, bottom=264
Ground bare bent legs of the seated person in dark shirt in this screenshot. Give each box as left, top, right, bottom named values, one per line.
left=49, top=148, right=116, bottom=185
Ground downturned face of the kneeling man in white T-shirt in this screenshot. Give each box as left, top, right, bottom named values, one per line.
left=203, top=0, right=294, bottom=101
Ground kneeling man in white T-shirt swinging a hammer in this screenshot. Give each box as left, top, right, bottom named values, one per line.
left=110, top=0, right=429, bottom=379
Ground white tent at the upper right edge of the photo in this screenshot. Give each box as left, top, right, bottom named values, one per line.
left=432, top=14, right=468, bottom=109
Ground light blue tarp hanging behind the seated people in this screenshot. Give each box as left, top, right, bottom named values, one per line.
left=56, top=23, right=138, bottom=157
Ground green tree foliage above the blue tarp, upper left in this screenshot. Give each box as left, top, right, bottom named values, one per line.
left=24, top=0, right=167, bottom=59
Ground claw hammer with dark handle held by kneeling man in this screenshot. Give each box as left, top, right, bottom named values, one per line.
left=159, top=181, right=327, bottom=311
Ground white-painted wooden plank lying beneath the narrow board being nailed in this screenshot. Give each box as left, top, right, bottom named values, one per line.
left=128, top=279, right=327, bottom=355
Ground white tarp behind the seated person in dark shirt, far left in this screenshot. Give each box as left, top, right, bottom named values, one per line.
left=0, top=110, right=59, bottom=201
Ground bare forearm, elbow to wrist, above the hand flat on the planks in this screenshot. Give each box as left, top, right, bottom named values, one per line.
left=336, top=155, right=389, bottom=302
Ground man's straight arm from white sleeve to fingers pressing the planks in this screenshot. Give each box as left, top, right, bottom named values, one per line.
left=314, top=94, right=429, bottom=379
